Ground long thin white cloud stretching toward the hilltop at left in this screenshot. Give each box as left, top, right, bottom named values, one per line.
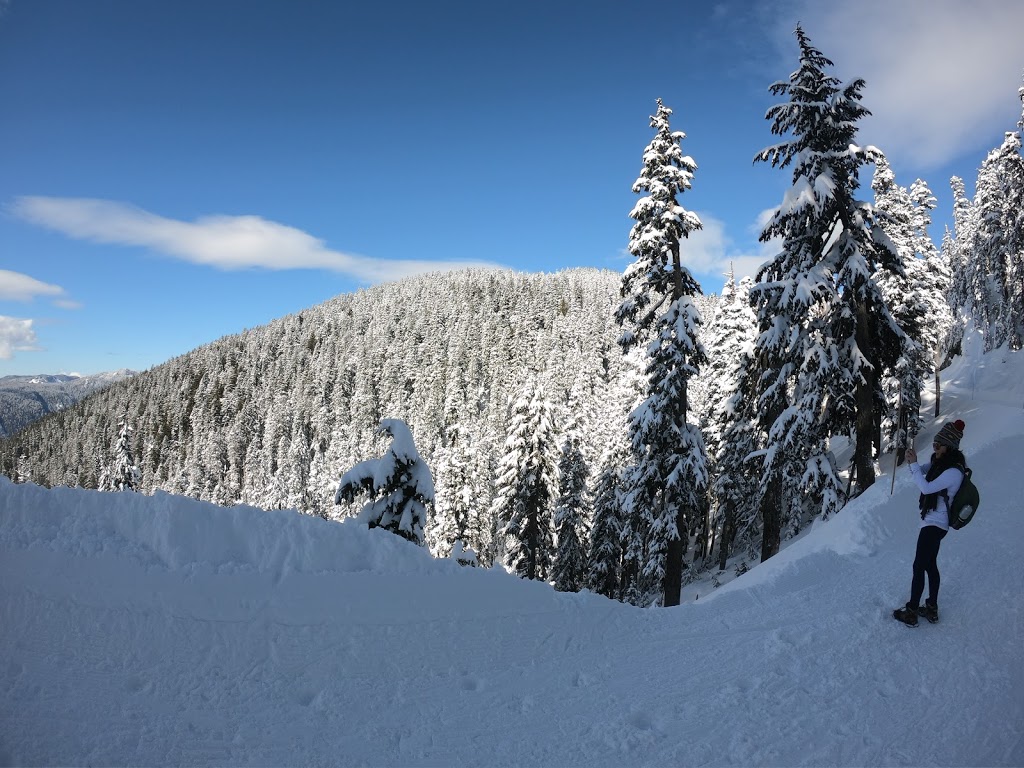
left=13, top=197, right=496, bottom=283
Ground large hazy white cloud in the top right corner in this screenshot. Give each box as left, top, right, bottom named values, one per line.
left=786, top=0, right=1024, bottom=170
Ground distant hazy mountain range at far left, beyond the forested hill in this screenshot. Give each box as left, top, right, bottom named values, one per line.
left=0, top=369, right=136, bottom=437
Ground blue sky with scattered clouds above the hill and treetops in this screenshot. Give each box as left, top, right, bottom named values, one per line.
left=0, top=0, right=1024, bottom=376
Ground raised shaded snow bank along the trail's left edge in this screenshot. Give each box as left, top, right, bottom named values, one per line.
left=0, top=477, right=448, bottom=579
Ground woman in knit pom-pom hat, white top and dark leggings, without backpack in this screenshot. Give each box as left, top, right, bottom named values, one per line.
left=893, top=419, right=967, bottom=627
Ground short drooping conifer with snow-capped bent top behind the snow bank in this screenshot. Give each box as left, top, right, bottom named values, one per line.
left=334, top=419, right=434, bottom=547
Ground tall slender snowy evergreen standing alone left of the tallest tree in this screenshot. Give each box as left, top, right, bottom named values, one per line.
left=615, top=99, right=708, bottom=605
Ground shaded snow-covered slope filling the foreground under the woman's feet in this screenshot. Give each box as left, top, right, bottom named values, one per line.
left=0, top=339, right=1024, bottom=766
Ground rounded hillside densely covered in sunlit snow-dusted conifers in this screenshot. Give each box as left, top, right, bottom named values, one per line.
left=0, top=269, right=714, bottom=555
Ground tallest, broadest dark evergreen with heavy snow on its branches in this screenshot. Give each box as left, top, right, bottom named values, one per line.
left=752, top=27, right=907, bottom=559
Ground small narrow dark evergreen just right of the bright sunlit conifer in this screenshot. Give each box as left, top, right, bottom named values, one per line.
left=551, top=429, right=591, bottom=592
